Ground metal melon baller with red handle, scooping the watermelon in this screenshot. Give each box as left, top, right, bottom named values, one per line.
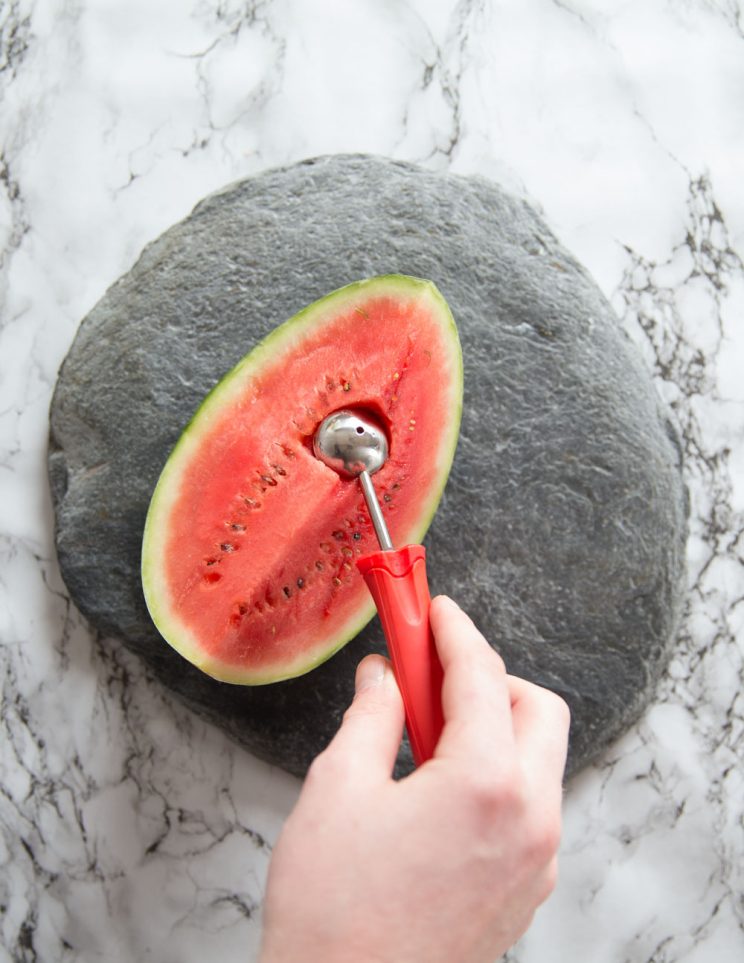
left=313, top=410, right=444, bottom=766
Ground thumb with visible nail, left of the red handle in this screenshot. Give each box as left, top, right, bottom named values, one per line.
left=326, top=655, right=404, bottom=778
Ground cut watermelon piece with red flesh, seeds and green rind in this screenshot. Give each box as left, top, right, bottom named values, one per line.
left=142, top=275, right=462, bottom=685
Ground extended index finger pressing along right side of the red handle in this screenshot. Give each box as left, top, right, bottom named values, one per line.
left=430, top=596, right=513, bottom=763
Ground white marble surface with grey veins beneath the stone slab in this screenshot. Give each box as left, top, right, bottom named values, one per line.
left=0, top=0, right=744, bottom=963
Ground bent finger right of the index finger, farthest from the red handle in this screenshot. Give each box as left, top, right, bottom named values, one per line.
left=507, top=676, right=571, bottom=790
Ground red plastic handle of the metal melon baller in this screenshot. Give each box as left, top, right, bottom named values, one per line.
left=357, top=545, right=444, bottom=766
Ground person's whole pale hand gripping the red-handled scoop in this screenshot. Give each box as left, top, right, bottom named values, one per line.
left=260, top=596, right=569, bottom=963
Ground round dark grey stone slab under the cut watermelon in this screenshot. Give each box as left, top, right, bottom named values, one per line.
left=49, top=156, right=687, bottom=774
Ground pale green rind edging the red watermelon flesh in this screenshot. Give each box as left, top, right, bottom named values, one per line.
left=141, top=274, right=463, bottom=686
